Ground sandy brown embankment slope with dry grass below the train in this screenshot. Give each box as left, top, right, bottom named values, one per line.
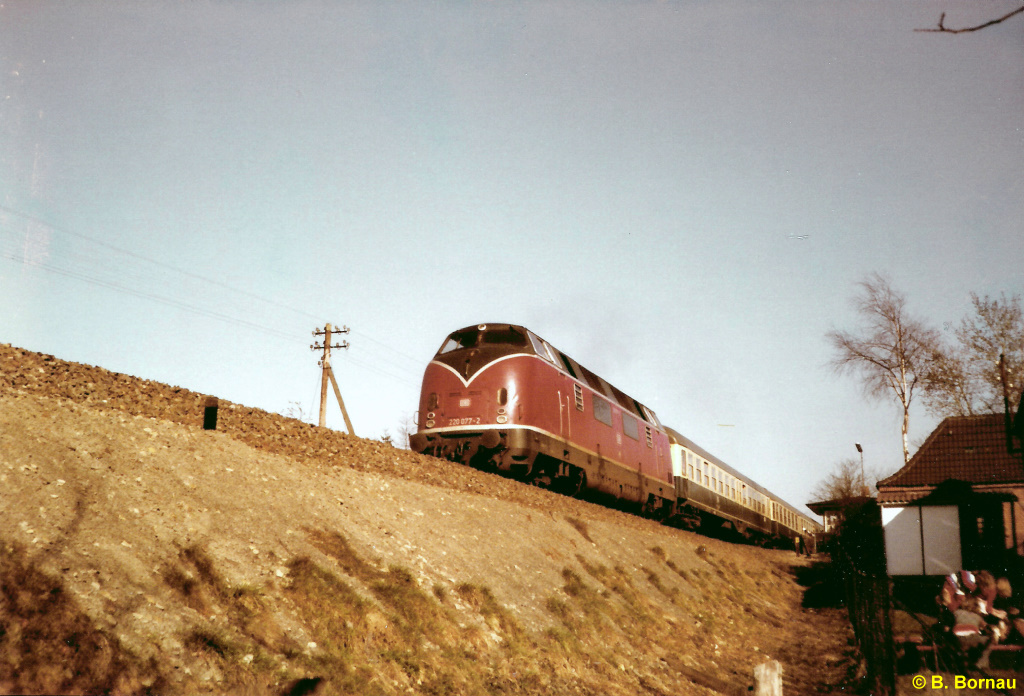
left=0, top=345, right=850, bottom=695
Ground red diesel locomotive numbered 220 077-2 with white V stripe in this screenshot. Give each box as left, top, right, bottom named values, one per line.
left=411, top=323, right=676, bottom=516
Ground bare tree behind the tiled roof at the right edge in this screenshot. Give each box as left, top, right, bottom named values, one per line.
left=925, top=293, right=1024, bottom=416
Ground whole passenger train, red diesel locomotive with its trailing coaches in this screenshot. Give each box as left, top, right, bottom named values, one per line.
left=410, top=323, right=818, bottom=543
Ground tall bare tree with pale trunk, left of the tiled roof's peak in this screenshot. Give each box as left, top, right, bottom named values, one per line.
left=826, top=272, right=939, bottom=464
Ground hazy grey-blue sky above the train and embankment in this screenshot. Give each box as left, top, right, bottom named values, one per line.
left=0, top=0, right=1024, bottom=515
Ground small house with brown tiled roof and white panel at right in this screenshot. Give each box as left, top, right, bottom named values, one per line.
left=878, top=414, right=1024, bottom=574
